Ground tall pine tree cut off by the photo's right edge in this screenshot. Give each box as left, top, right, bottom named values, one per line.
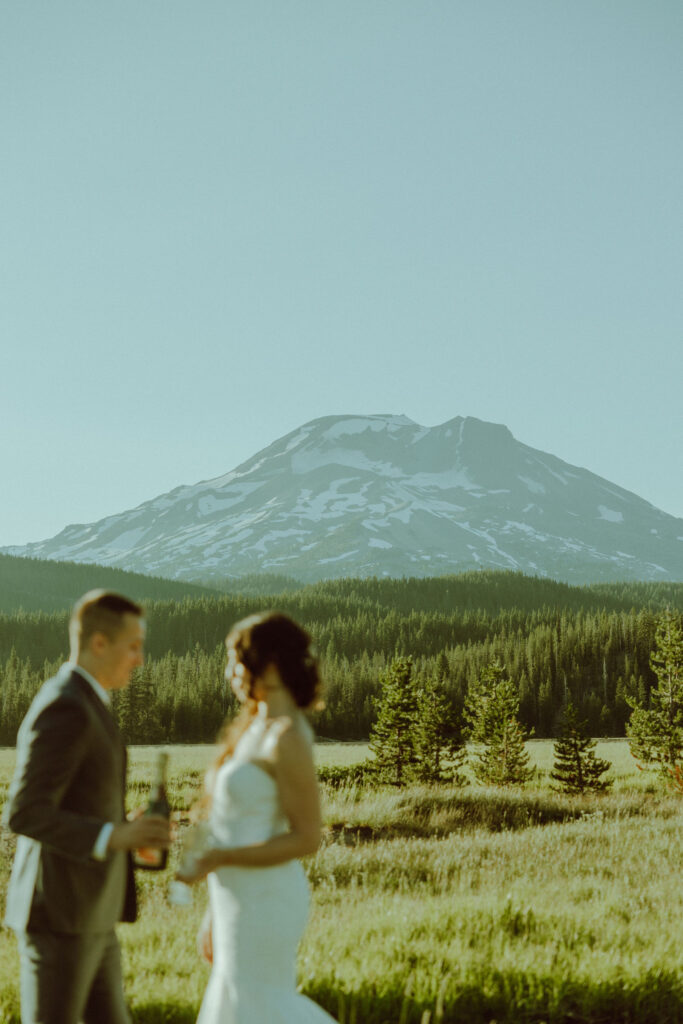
left=627, top=609, right=683, bottom=777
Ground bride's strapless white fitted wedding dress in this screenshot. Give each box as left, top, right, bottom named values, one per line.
left=197, top=722, right=334, bottom=1024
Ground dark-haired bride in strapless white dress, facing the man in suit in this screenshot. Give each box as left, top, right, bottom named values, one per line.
left=178, top=612, right=333, bottom=1024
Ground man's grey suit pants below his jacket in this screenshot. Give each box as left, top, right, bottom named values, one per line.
left=17, top=929, right=130, bottom=1024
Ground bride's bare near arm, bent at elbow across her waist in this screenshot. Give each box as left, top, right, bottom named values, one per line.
left=183, top=728, right=321, bottom=882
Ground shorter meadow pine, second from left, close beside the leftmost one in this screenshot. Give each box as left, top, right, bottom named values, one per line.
left=414, top=679, right=467, bottom=784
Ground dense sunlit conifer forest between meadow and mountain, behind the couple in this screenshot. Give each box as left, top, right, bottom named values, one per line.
left=0, top=572, right=683, bottom=744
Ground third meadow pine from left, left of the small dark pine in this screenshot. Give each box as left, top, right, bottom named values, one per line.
left=465, top=660, right=533, bottom=785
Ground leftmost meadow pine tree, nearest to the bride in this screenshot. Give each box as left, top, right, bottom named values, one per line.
left=370, top=657, right=418, bottom=785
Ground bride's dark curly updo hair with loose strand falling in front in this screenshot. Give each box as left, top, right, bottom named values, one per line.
left=216, top=611, right=323, bottom=766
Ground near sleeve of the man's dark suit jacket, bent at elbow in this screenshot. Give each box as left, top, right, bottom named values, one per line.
left=7, top=697, right=105, bottom=860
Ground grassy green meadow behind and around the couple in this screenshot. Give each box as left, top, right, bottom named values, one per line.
left=0, top=740, right=683, bottom=1024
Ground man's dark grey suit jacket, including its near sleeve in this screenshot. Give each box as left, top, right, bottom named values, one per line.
left=5, top=666, right=135, bottom=934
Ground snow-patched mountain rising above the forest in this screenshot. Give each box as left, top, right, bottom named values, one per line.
left=3, top=416, right=683, bottom=583
